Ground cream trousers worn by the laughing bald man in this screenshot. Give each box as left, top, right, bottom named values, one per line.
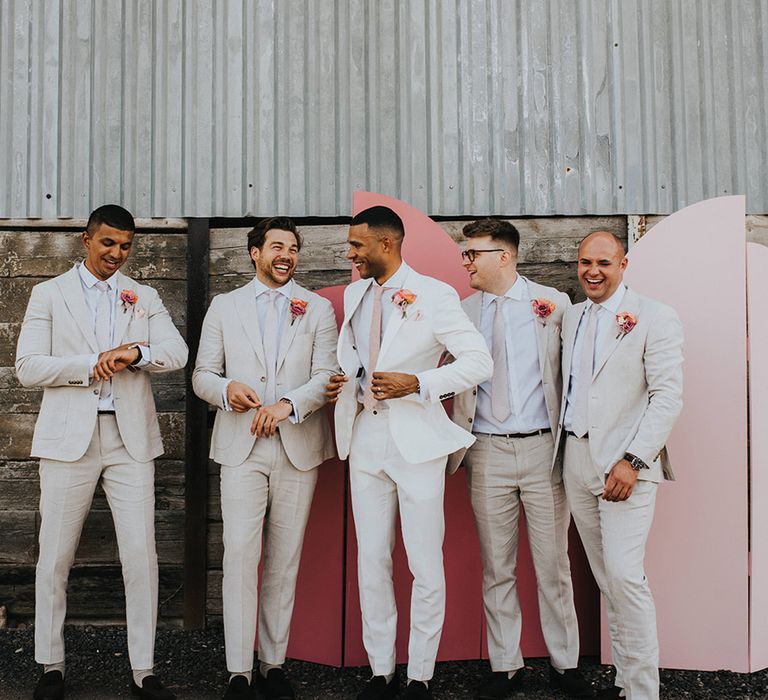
left=563, top=435, right=659, bottom=700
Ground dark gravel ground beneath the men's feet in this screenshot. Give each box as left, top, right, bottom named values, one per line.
left=0, top=625, right=768, bottom=700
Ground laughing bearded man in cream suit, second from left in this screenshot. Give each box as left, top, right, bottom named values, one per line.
left=192, top=217, right=337, bottom=700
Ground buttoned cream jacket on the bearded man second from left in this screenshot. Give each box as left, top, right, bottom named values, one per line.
left=192, top=283, right=337, bottom=471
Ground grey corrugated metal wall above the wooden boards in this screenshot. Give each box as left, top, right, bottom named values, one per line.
left=0, top=0, right=768, bottom=218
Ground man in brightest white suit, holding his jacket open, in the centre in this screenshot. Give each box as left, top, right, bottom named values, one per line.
left=328, top=207, right=492, bottom=700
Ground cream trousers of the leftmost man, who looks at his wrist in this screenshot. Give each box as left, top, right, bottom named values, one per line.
left=35, top=414, right=157, bottom=670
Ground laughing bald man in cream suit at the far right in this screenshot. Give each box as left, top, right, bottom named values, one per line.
left=556, top=231, right=683, bottom=700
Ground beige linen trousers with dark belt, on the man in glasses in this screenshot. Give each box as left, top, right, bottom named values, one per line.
left=464, top=433, right=579, bottom=671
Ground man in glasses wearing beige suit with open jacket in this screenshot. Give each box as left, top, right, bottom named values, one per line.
left=448, top=219, right=592, bottom=700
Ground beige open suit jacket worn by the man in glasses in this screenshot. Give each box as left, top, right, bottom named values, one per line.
left=448, top=280, right=571, bottom=474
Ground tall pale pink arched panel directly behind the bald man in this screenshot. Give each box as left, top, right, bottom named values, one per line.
left=620, top=196, right=748, bottom=672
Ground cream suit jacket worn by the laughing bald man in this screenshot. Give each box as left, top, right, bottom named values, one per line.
left=555, top=289, right=683, bottom=482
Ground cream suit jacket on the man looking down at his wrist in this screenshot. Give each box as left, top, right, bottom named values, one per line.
left=16, top=266, right=187, bottom=462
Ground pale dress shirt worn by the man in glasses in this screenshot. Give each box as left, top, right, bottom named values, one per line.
left=472, top=275, right=550, bottom=434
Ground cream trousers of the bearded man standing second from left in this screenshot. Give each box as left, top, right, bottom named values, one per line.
left=221, top=434, right=317, bottom=673
